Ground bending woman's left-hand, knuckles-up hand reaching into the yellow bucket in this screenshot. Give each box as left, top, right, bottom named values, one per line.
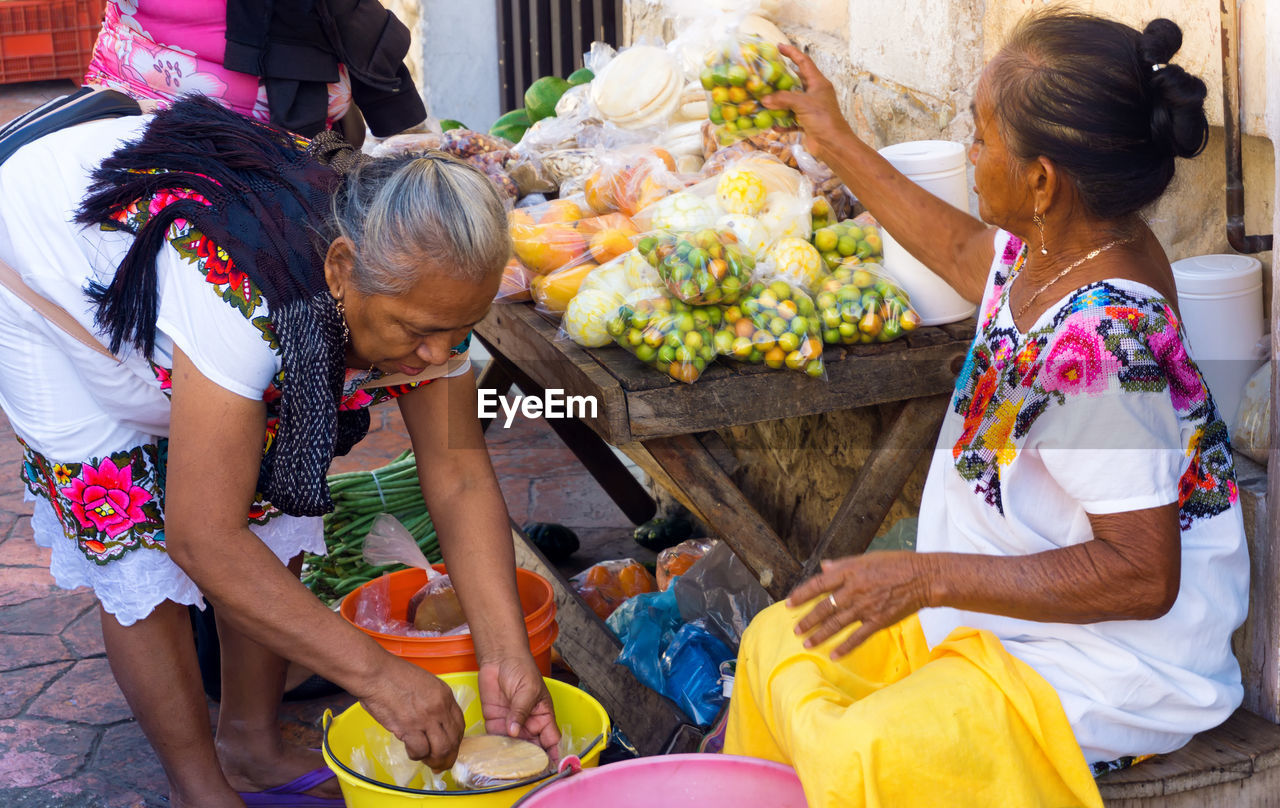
left=360, top=654, right=466, bottom=772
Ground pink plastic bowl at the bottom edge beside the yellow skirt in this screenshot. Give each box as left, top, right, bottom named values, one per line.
left=516, top=754, right=808, bottom=808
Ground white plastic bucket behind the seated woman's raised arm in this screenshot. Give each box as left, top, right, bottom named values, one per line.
left=881, top=141, right=978, bottom=325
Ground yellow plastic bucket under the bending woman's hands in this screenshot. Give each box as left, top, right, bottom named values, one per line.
left=323, top=672, right=609, bottom=808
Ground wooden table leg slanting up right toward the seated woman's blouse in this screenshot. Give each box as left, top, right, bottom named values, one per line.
left=803, top=396, right=951, bottom=578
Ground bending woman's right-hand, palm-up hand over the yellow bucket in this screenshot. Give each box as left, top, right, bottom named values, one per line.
left=480, top=653, right=559, bottom=762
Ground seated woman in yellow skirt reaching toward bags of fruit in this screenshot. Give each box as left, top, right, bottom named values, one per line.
left=724, top=12, right=1248, bottom=807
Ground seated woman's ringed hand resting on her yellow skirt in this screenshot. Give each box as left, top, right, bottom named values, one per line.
left=787, top=552, right=931, bottom=659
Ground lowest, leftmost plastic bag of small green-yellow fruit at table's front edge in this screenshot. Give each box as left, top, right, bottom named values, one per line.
left=607, top=289, right=722, bottom=383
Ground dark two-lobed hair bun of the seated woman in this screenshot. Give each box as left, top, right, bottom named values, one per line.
left=1138, top=18, right=1208, bottom=158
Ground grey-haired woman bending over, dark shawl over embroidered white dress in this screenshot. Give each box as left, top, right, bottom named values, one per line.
left=0, top=97, right=558, bottom=808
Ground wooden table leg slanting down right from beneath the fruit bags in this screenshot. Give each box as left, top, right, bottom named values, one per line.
left=637, top=435, right=800, bottom=599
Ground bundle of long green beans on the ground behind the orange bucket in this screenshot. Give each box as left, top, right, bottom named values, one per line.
left=302, top=452, right=440, bottom=604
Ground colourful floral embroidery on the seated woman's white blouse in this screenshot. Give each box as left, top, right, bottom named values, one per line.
left=951, top=237, right=1239, bottom=530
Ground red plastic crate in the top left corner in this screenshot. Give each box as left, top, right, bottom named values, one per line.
left=0, top=0, right=106, bottom=85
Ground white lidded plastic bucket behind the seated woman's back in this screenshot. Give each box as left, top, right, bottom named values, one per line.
left=1174, top=255, right=1266, bottom=426
